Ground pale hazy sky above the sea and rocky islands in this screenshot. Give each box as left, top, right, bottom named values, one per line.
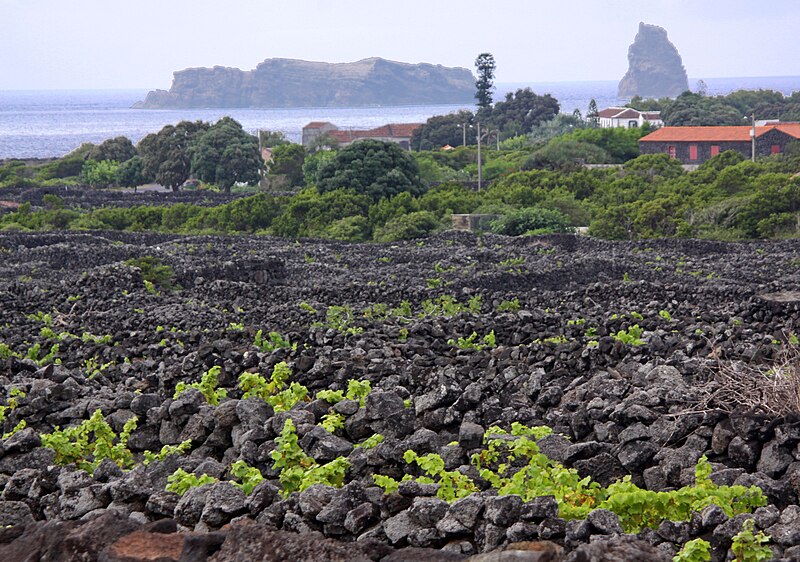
left=0, top=0, right=800, bottom=90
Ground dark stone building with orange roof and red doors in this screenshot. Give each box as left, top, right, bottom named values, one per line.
left=639, top=123, right=800, bottom=164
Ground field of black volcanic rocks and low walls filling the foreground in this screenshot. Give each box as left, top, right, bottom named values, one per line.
left=0, top=232, right=800, bottom=562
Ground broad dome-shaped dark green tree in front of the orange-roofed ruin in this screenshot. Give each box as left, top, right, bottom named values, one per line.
left=317, top=139, right=424, bottom=201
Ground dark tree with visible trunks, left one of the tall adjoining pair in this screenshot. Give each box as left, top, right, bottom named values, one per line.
left=137, top=121, right=209, bottom=191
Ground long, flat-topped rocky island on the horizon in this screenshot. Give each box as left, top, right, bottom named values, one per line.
left=133, top=58, right=475, bottom=109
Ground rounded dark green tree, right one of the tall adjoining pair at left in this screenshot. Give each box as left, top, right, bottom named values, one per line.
left=189, top=117, right=262, bottom=193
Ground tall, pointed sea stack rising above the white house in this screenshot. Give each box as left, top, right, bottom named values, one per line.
left=617, top=23, right=689, bottom=98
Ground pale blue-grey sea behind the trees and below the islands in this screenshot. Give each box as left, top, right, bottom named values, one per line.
left=0, top=76, right=800, bottom=159
